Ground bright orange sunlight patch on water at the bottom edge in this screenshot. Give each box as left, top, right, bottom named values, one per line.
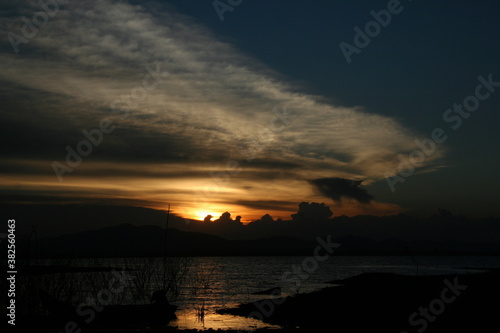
left=169, top=310, right=281, bottom=330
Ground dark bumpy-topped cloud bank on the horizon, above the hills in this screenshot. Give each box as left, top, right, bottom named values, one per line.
left=6, top=203, right=500, bottom=243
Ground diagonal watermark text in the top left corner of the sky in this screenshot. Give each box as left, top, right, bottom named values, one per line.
left=7, top=0, right=68, bottom=53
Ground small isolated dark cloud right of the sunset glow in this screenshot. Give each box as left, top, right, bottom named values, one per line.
left=309, top=178, right=373, bottom=203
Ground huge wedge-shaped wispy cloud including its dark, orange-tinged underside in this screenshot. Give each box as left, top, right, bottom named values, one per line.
left=0, top=0, right=446, bottom=217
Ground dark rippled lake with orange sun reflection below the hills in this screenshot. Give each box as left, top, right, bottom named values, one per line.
left=27, top=255, right=500, bottom=330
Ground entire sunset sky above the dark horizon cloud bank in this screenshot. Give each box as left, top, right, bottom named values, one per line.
left=0, top=0, right=500, bottom=222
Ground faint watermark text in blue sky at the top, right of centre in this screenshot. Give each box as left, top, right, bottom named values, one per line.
left=339, top=0, right=411, bottom=64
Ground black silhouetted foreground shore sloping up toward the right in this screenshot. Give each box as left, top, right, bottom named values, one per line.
left=16, top=269, right=500, bottom=333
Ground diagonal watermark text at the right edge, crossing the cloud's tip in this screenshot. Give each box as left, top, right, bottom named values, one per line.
left=384, top=74, right=500, bottom=193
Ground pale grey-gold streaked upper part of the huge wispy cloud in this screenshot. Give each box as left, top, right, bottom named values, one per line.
left=0, top=1, right=440, bottom=172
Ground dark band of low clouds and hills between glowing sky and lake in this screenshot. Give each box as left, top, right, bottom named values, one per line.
left=0, top=203, right=500, bottom=256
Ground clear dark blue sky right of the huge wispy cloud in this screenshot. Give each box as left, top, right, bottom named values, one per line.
left=161, top=0, right=500, bottom=213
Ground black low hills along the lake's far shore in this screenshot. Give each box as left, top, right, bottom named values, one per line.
left=19, top=224, right=500, bottom=257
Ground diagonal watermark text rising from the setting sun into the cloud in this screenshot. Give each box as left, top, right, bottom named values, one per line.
left=189, top=106, right=296, bottom=224
